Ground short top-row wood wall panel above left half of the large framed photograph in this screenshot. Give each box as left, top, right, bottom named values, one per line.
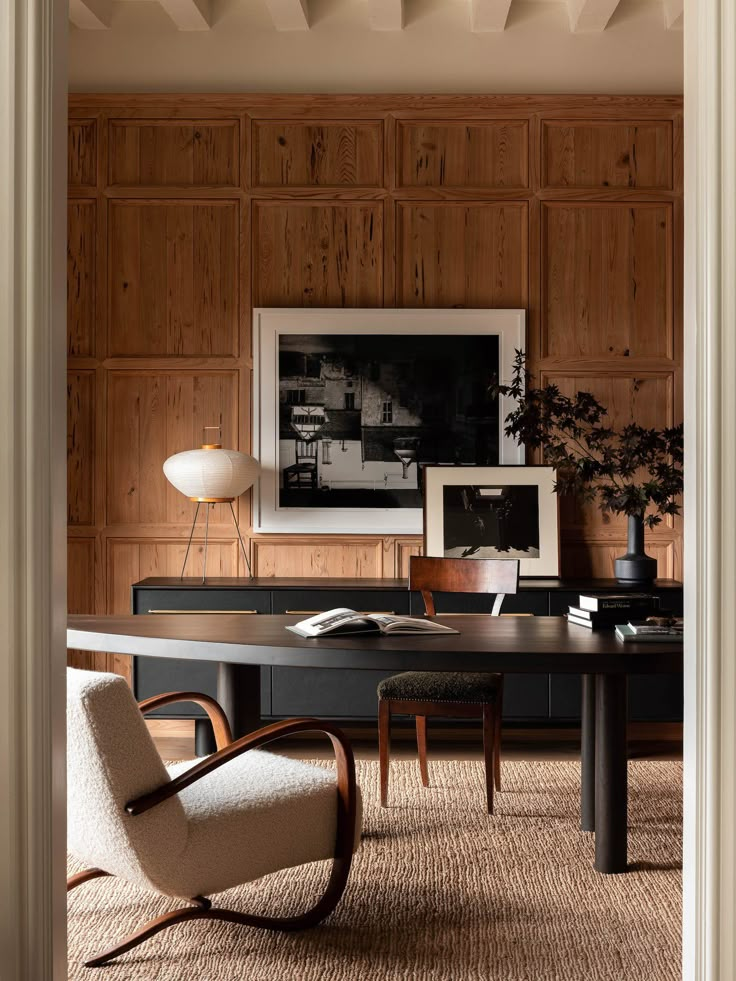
left=252, top=120, right=383, bottom=187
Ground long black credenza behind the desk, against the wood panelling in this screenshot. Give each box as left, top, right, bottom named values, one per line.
left=132, top=578, right=683, bottom=735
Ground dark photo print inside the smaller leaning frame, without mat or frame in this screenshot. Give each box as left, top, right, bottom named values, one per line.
left=442, top=484, right=540, bottom=559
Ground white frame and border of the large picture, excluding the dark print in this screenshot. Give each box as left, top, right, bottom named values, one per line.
left=253, top=308, right=526, bottom=535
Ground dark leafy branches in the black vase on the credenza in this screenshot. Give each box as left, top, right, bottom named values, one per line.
left=493, top=351, right=683, bottom=528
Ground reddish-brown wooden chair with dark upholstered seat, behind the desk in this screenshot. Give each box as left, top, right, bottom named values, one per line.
left=378, top=555, right=519, bottom=814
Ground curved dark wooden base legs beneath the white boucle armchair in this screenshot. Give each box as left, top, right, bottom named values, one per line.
left=66, top=851, right=352, bottom=967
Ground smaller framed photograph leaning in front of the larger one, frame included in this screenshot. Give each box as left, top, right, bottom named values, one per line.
left=424, top=466, right=560, bottom=576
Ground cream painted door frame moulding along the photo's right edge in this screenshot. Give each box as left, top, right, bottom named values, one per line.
left=683, top=0, right=736, bottom=981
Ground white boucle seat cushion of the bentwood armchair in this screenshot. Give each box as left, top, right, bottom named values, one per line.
left=165, top=750, right=361, bottom=897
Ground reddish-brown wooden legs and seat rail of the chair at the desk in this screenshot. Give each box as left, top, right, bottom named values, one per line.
left=378, top=689, right=502, bottom=814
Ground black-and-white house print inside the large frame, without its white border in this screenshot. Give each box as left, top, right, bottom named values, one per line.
left=278, top=334, right=499, bottom=508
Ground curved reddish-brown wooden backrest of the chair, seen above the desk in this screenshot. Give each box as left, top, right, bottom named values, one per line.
left=409, top=555, right=519, bottom=616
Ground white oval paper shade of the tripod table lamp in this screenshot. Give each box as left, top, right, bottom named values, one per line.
left=164, top=447, right=260, bottom=501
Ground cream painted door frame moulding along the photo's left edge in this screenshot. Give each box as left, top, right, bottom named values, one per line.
left=0, top=0, right=68, bottom=981
